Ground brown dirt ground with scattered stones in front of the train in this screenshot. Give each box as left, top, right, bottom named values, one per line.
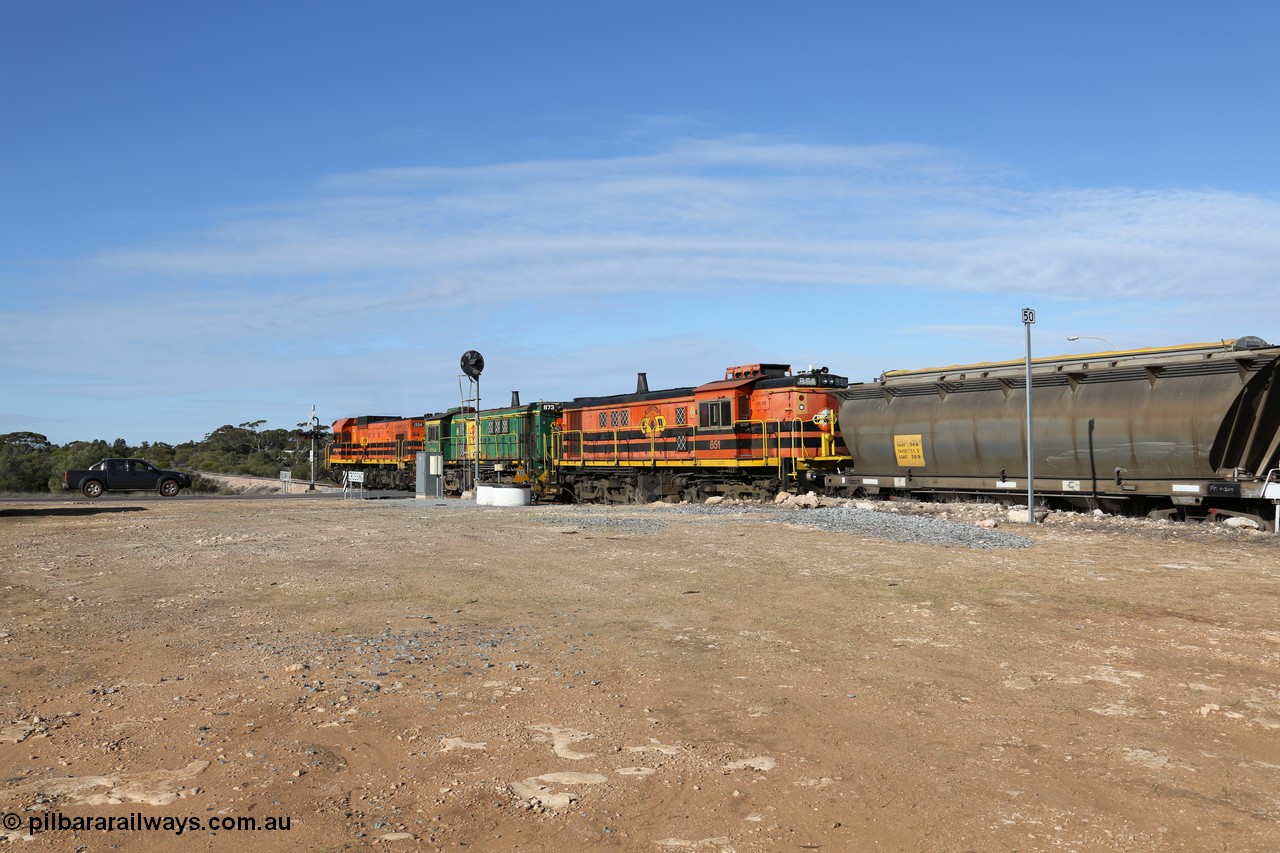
left=0, top=496, right=1280, bottom=853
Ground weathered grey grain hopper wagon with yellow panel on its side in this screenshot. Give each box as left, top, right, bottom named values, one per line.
left=837, top=338, right=1280, bottom=506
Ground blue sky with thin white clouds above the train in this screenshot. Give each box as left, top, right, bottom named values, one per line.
left=0, top=0, right=1280, bottom=443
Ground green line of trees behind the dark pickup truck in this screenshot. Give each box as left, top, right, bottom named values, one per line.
left=0, top=420, right=329, bottom=493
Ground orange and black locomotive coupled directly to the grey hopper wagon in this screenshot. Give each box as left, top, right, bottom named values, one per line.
left=540, top=364, right=852, bottom=503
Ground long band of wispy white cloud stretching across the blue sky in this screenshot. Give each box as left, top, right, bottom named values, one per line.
left=90, top=138, right=1280, bottom=304
